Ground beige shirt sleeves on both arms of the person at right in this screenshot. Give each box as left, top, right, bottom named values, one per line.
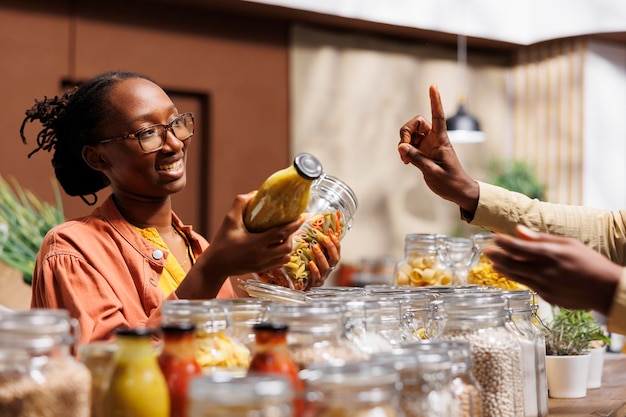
left=470, top=182, right=626, bottom=334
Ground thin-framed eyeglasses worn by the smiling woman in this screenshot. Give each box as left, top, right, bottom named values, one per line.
left=98, top=113, right=194, bottom=153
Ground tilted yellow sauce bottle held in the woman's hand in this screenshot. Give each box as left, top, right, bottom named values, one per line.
left=244, top=153, right=322, bottom=232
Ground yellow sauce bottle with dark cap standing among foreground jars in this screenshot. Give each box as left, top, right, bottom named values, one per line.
left=105, top=328, right=170, bottom=417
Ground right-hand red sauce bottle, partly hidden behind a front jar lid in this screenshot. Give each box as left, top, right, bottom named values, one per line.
left=248, top=322, right=304, bottom=416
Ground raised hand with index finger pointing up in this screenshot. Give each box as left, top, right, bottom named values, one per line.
left=398, top=85, right=479, bottom=216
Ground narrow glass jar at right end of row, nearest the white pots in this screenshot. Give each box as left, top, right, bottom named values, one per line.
left=503, top=290, right=548, bottom=417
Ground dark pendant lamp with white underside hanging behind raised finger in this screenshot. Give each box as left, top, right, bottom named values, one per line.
left=446, top=35, right=485, bottom=143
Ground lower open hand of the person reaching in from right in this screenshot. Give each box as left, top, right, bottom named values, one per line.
left=485, top=225, right=623, bottom=315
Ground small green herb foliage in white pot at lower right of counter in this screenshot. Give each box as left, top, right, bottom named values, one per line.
left=545, top=307, right=610, bottom=356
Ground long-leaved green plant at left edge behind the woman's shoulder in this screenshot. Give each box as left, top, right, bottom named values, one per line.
left=0, top=176, right=64, bottom=284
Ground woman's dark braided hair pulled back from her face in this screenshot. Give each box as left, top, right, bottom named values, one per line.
left=20, top=71, right=149, bottom=205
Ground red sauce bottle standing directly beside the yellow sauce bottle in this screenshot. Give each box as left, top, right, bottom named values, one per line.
left=159, top=323, right=202, bottom=417
